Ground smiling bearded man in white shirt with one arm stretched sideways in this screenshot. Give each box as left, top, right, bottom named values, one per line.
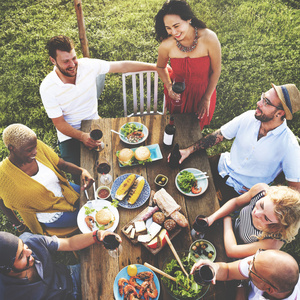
left=40, top=35, right=156, bottom=180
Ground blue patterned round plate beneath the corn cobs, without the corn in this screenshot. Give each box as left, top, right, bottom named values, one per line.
left=111, top=173, right=151, bottom=209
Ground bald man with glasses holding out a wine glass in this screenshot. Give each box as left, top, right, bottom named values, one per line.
left=191, top=249, right=300, bottom=300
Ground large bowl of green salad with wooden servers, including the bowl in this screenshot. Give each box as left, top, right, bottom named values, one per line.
left=161, top=251, right=209, bottom=300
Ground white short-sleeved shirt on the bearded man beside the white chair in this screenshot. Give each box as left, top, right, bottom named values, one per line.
left=40, top=58, right=110, bottom=142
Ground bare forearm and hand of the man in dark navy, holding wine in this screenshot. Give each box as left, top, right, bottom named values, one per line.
left=58, top=230, right=122, bottom=251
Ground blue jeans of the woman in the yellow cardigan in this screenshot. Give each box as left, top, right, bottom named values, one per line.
left=44, top=182, right=80, bottom=228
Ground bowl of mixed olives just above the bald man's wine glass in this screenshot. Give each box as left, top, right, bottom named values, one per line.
left=190, top=239, right=217, bottom=261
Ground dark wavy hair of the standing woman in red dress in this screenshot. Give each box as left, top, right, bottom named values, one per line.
left=155, top=0, right=206, bottom=42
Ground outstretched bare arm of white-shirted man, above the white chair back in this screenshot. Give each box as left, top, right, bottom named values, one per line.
left=109, top=60, right=156, bottom=73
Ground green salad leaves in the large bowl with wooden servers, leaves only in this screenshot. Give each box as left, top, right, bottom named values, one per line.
left=162, top=254, right=205, bottom=299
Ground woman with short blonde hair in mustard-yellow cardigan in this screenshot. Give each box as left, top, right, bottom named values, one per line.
left=0, top=124, right=94, bottom=234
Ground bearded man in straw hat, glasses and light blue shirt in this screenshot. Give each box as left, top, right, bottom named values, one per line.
left=179, top=84, right=300, bottom=202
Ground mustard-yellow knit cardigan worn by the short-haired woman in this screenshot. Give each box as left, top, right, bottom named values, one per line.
left=0, top=140, right=79, bottom=234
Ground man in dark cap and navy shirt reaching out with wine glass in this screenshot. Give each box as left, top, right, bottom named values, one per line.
left=0, top=230, right=121, bottom=300
